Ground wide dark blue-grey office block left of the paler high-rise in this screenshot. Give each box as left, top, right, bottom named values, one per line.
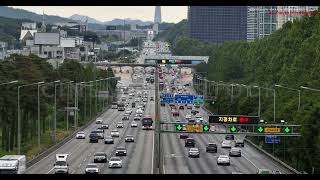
left=188, top=6, right=247, bottom=43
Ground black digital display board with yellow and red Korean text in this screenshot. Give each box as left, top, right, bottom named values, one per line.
left=209, top=115, right=259, bottom=124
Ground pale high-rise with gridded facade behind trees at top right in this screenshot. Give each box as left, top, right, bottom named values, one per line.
left=247, top=6, right=318, bottom=42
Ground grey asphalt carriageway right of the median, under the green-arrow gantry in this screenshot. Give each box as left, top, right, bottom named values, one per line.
left=160, top=69, right=290, bottom=174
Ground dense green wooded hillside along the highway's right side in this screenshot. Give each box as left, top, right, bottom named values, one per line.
left=174, top=11, right=320, bottom=174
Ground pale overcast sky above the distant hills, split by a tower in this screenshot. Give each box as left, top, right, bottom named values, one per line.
left=11, top=6, right=188, bottom=23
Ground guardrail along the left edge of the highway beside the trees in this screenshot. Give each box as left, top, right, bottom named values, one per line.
left=27, top=105, right=111, bottom=168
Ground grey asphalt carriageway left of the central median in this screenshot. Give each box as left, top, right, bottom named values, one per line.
left=26, top=73, right=155, bottom=174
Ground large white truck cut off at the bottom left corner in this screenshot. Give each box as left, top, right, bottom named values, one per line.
left=0, top=155, right=27, bottom=174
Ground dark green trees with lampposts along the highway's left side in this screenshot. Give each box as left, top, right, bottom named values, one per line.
left=0, top=55, right=117, bottom=160
